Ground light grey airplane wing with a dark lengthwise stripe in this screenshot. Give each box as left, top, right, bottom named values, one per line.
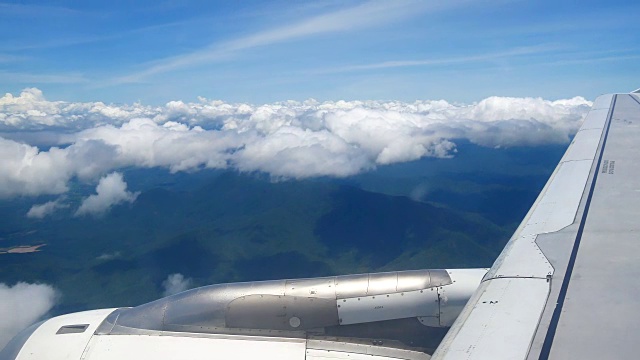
left=433, top=91, right=640, bottom=359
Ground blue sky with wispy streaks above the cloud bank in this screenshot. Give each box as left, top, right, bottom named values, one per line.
left=0, top=0, right=640, bottom=104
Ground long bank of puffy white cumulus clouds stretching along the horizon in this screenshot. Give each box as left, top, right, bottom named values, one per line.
left=0, top=88, right=591, bottom=200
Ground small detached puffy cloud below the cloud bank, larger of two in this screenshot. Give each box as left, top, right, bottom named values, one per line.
left=76, top=172, right=139, bottom=216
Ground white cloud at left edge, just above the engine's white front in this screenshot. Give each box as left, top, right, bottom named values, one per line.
left=0, top=282, right=57, bottom=349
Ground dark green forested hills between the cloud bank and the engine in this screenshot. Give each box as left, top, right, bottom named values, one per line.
left=0, top=173, right=510, bottom=312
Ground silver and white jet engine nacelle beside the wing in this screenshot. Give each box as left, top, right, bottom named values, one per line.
left=0, top=269, right=487, bottom=359
